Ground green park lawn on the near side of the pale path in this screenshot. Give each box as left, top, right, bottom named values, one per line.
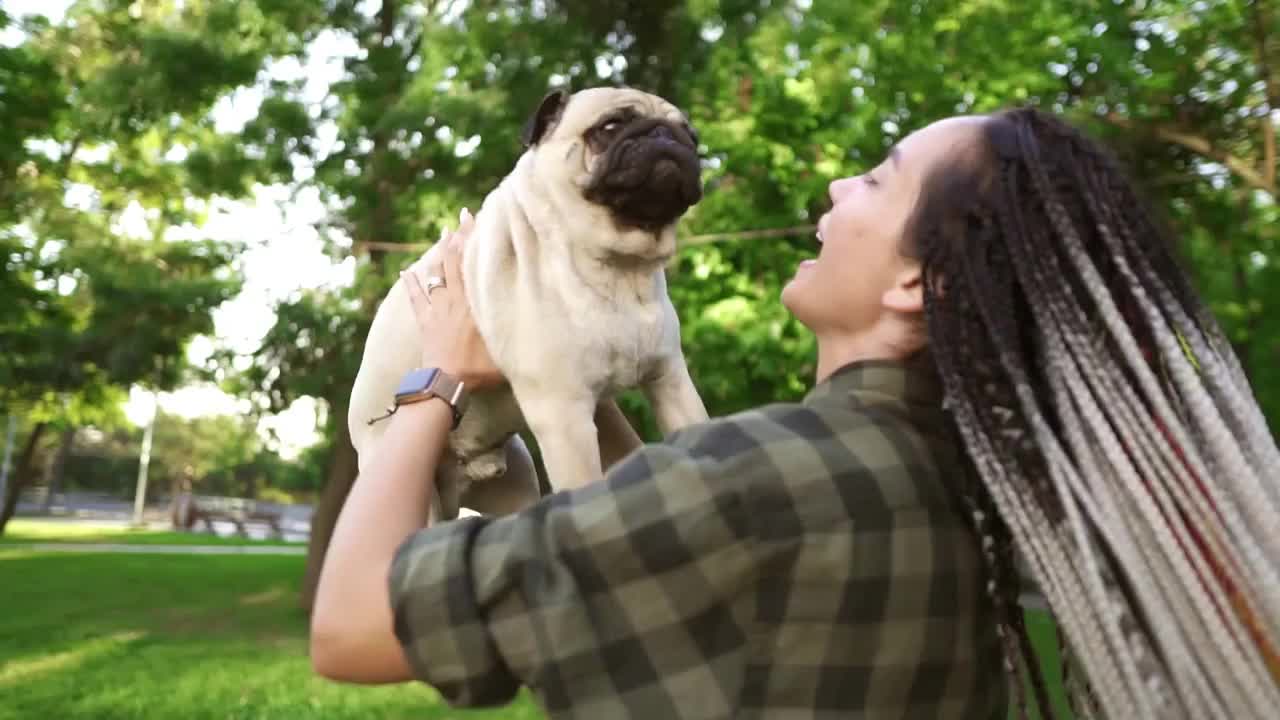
left=0, top=547, right=543, bottom=720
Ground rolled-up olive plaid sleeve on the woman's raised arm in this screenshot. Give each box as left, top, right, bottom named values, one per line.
left=389, top=430, right=756, bottom=707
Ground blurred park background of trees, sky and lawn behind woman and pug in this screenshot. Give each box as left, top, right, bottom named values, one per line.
left=0, top=0, right=1280, bottom=719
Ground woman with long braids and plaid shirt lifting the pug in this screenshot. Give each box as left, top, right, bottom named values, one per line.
left=312, top=110, right=1280, bottom=717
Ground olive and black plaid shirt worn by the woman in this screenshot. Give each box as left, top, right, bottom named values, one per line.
left=390, top=361, right=1005, bottom=720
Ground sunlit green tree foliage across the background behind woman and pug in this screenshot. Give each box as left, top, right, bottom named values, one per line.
left=0, top=0, right=1280, bottom=509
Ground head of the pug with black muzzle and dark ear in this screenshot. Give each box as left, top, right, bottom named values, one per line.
left=524, top=87, right=703, bottom=240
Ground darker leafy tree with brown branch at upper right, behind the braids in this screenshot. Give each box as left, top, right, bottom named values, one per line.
left=1064, top=0, right=1280, bottom=429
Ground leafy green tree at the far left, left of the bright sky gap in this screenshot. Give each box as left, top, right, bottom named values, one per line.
left=0, top=1, right=325, bottom=533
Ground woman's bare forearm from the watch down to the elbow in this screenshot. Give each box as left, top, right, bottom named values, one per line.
left=311, top=400, right=453, bottom=683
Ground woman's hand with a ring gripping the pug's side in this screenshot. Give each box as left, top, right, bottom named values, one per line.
left=401, top=209, right=504, bottom=389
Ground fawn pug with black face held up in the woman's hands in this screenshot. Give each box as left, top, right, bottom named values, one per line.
left=348, top=87, right=707, bottom=520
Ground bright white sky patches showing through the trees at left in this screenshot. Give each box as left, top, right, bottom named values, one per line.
left=10, top=0, right=355, bottom=457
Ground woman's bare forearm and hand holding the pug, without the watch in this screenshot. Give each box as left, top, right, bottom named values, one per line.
left=311, top=211, right=502, bottom=683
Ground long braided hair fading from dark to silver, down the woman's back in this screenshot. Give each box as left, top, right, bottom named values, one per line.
left=904, top=109, right=1280, bottom=719
